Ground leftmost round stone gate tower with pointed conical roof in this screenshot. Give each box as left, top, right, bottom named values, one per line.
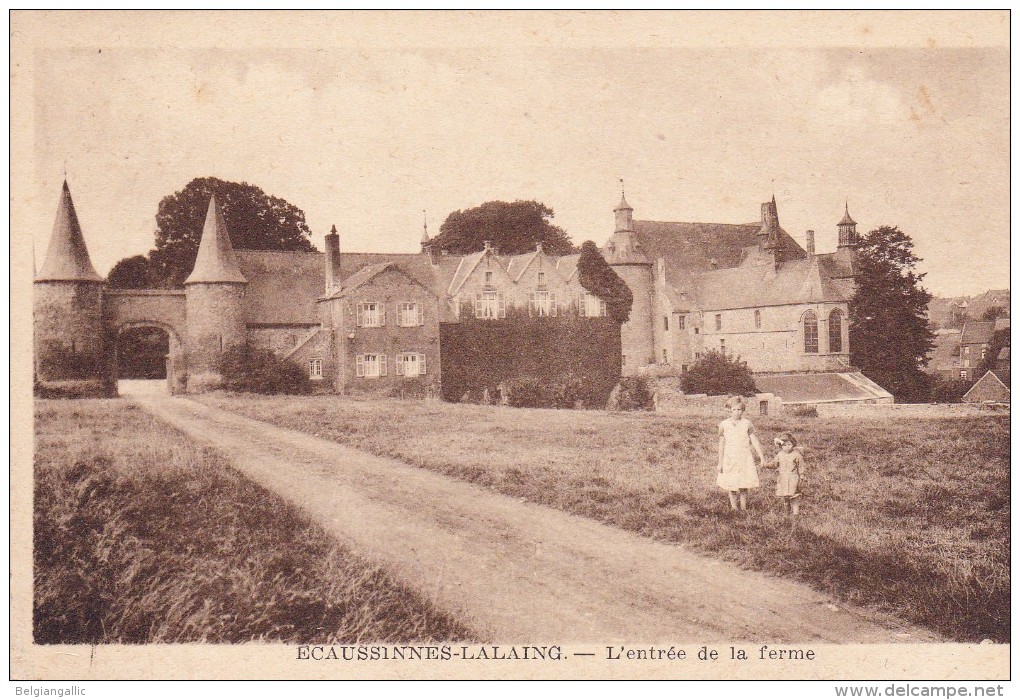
left=33, top=181, right=110, bottom=383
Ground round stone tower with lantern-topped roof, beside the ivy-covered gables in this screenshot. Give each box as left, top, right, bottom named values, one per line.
left=602, top=195, right=655, bottom=377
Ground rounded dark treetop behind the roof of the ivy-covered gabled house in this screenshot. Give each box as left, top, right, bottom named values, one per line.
left=434, top=200, right=576, bottom=255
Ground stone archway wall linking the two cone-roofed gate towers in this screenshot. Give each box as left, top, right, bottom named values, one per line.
left=103, top=289, right=188, bottom=394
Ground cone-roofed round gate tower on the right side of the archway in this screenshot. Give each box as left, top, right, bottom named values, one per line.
left=185, top=196, right=248, bottom=392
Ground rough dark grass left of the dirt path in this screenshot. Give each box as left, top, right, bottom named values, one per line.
left=34, top=400, right=471, bottom=644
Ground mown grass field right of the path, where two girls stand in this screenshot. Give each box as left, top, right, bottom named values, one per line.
left=201, top=394, right=1010, bottom=643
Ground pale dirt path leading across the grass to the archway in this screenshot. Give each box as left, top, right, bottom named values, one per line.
left=125, top=395, right=934, bottom=644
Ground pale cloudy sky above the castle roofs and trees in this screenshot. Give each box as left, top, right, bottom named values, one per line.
left=19, top=13, right=1010, bottom=296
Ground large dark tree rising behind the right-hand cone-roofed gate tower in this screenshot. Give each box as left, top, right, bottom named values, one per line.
left=149, top=178, right=315, bottom=287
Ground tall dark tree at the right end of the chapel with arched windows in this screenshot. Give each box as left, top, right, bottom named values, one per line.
left=850, top=227, right=934, bottom=402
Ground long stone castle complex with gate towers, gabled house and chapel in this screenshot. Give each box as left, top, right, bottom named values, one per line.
left=35, top=184, right=891, bottom=402
